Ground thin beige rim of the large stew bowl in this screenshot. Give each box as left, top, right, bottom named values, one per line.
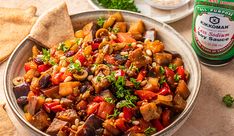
left=3, top=9, right=201, bottom=136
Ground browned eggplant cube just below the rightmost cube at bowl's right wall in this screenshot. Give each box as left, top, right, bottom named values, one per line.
left=173, top=93, right=187, bottom=112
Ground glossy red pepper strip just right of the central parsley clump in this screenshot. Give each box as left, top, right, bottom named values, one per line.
left=135, top=90, right=157, bottom=100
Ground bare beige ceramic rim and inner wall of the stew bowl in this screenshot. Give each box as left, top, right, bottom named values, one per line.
left=4, top=10, right=201, bottom=135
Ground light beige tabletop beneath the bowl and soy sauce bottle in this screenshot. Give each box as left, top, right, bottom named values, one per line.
left=0, top=0, right=234, bottom=136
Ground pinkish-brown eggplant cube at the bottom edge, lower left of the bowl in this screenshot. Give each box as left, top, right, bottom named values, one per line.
left=46, top=118, right=68, bottom=135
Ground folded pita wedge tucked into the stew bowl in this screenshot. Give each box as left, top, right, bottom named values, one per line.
left=29, top=2, right=74, bottom=48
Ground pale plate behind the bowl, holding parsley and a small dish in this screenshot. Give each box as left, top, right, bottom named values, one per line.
left=88, top=0, right=194, bottom=23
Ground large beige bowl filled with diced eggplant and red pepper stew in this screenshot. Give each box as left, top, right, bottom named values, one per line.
left=4, top=10, right=201, bottom=136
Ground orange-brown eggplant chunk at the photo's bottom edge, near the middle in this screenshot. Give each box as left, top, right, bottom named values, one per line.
left=103, top=119, right=121, bottom=136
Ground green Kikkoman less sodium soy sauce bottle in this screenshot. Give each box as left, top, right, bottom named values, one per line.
left=192, top=0, right=234, bottom=66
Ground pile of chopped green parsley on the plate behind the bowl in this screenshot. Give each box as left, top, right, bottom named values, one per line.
left=98, top=0, right=139, bottom=12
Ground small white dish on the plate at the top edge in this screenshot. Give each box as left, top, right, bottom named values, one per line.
left=145, top=0, right=190, bottom=10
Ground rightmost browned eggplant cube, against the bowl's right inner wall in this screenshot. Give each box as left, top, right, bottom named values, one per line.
left=175, top=80, right=190, bottom=100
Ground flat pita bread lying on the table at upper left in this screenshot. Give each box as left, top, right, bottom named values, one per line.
left=0, top=7, right=37, bottom=62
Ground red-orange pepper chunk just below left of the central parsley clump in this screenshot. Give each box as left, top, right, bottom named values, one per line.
left=97, top=102, right=115, bottom=119
